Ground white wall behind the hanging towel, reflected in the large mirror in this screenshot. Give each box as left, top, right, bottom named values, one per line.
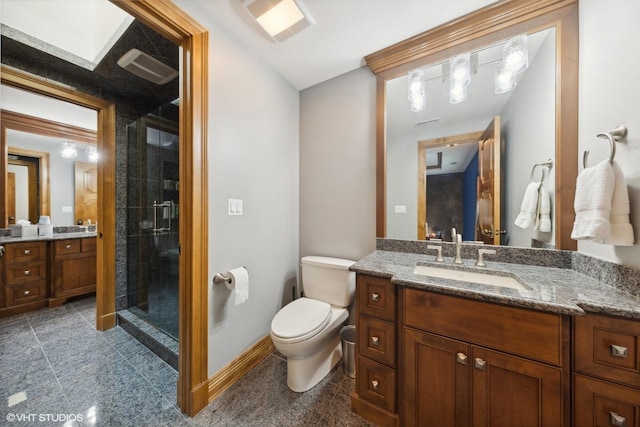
left=501, top=30, right=556, bottom=247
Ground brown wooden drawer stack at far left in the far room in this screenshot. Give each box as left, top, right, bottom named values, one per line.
left=0, top=242, right=48, bottom=314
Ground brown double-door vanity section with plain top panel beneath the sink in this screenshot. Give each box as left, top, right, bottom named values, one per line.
left=401, top=288, right=570, bottom=426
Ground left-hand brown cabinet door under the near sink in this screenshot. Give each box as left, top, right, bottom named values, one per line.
left=403, top=328, right=470, bottom=427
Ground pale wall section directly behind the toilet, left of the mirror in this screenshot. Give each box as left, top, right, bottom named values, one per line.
left=300, top=68, right=376, bottom=260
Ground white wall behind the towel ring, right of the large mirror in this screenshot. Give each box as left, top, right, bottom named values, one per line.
left=578, top=0, right=640, bottom=268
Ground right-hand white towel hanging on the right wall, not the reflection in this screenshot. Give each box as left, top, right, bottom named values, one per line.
left=599, top=161, right=634, bottom=246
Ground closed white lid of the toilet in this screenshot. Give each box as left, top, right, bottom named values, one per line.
left=271, top=298, right=331, bottom=339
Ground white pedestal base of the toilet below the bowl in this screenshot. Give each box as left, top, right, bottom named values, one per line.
left=287, top=335, right=342, bottom=392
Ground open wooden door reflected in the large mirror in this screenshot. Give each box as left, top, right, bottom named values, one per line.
left=477, top=116, right=502, bottom=245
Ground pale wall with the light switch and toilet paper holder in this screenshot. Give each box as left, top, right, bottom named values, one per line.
left=176, top=0, right=299, bottom=375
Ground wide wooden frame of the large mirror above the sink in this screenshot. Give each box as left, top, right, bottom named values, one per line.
left=365, top=0, right=579, bottom=251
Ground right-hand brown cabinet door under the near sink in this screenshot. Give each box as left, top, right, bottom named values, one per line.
left=469, top=347, right=563, bottom=427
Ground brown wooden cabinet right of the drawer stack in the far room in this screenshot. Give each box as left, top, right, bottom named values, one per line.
left=49, top=237, right=97, bottom=307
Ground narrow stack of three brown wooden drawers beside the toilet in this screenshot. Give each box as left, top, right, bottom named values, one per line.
left=351, top=274, right=399, bottom=425
